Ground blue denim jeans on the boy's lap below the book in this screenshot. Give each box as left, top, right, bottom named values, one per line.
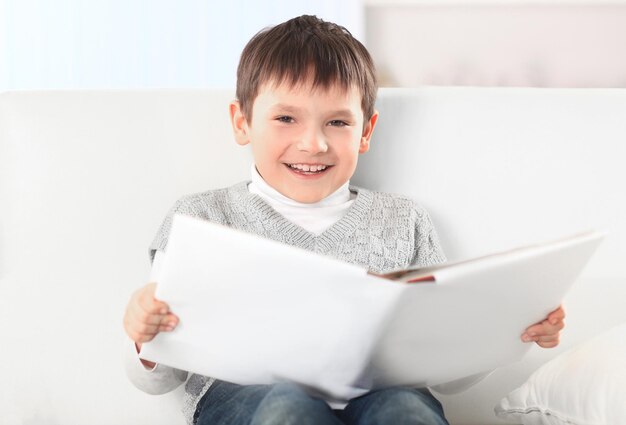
left=195, top=380, right=448, bottom=425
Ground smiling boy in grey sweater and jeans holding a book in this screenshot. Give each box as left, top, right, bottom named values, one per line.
left=124, top=16, right=563, bottom=424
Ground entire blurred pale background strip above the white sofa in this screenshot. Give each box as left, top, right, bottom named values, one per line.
left=0, top=0, right=626, bottom=91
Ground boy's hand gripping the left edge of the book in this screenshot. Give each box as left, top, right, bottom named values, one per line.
left=124, top=282, right=178, bottom=350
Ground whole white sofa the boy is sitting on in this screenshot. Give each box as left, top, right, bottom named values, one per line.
left=0, top=88, right=626, bottom=425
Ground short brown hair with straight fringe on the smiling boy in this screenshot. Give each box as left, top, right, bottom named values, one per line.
left=237, top=15, right=377, bottom=121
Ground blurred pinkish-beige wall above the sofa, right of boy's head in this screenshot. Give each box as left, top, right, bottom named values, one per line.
left=366, top=0, right=626, bottom=87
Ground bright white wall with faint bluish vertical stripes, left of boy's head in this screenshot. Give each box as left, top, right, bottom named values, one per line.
left=0, top=0, right=364, bottom=91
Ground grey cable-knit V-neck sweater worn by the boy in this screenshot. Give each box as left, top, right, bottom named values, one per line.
left=134, top=182, right=445, bottom=424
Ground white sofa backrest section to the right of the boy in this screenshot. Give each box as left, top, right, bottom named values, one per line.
left=354, top=88, right=626, bottom=277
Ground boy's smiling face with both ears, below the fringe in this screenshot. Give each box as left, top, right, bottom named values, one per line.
left=230, top=83, right=378, bottom=203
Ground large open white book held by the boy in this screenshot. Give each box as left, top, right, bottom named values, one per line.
left=140, top=216, right=602, bottom=400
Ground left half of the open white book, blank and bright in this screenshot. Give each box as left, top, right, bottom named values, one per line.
left=141, top=216, right=404, bottom=399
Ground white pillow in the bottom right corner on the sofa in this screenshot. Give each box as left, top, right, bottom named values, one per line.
left=495, top=323, right=626, bottom=425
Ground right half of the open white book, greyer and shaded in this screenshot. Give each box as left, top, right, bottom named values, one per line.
left=371, top=232, right=603, bottom=387
